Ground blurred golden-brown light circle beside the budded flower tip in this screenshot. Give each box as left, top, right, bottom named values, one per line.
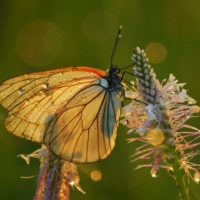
left=145, top=43, right=167, bottom=64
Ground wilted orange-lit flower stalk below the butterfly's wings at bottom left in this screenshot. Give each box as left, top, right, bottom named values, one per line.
left=19, top=146, right=85, bottom=200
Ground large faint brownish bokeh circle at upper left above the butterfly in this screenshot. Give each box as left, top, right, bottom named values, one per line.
left=16, top=21, right=63, bottom=66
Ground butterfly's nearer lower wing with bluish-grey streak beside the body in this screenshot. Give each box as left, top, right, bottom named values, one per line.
left=44, top=78, right=121, bottom=163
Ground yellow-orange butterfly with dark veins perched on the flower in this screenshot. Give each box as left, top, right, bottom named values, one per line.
left=0, top=26, right=125, bottom=163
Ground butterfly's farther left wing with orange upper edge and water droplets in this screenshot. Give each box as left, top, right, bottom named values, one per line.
left=0, top=67, right=105, bottom=143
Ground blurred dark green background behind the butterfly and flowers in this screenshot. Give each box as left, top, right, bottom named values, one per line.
left=0, top=0, right=200, bottom=200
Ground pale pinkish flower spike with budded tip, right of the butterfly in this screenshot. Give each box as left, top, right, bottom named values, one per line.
left=122, top=47, right=200, bottom=183
